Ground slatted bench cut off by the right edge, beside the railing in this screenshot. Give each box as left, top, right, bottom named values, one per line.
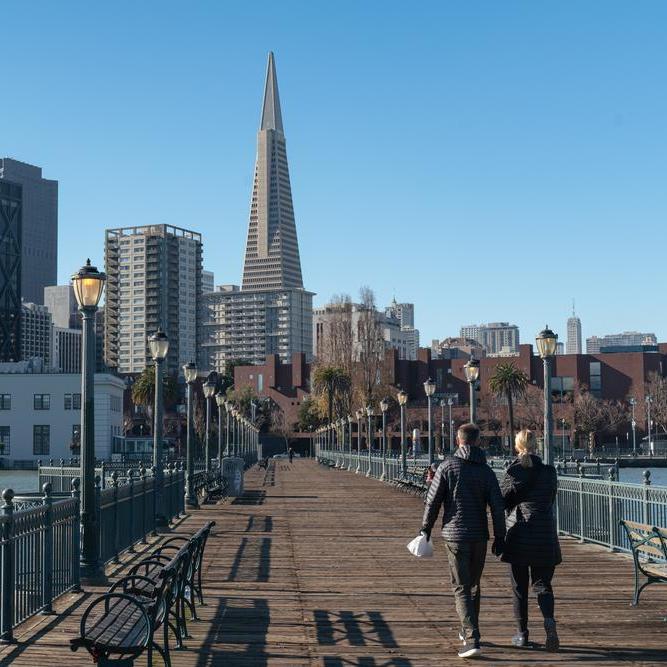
left=620, top=519, right=667, bottom=606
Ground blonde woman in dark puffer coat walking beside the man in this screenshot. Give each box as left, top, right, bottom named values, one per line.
left=501, top=430, right=561, bottom=651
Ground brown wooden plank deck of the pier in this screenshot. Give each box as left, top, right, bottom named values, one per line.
left=0, top=460, right=667, bottom=667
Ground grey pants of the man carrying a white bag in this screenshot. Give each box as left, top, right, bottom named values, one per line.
left=445, top=540, right=486, bottom=639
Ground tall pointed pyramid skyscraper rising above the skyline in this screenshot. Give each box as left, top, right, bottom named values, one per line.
left=241, top=53, right=303, bottom=290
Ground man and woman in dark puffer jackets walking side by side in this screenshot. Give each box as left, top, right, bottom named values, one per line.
left=421, top=424, right=561, bottom=658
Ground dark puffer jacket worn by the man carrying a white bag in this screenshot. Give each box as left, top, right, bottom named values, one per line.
left=422, top=446, right=505, bottom=542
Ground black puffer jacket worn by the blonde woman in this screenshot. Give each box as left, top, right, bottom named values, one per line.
left=501, top=454, right=561, bottom=567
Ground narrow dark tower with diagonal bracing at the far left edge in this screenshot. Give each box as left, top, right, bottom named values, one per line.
left=0, top=180, right=23, bottom=362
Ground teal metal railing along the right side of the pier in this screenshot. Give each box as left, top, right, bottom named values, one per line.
left=318, top=449, right=667, bottom=552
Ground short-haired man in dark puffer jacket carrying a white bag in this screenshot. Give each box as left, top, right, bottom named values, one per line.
left=422, top=424, right=505, bottom=658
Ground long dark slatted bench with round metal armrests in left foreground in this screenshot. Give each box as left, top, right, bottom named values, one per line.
left=70, top=521, right=215, bottom=667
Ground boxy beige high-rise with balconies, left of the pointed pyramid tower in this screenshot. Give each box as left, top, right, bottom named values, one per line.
left=104, top=225, right=202, bottom=375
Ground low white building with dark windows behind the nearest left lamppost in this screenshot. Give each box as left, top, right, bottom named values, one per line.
left=0, top=374, right=125, bottom=467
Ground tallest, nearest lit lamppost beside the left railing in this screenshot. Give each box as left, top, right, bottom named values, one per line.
left=72, top=260, right=106, bottom=581
